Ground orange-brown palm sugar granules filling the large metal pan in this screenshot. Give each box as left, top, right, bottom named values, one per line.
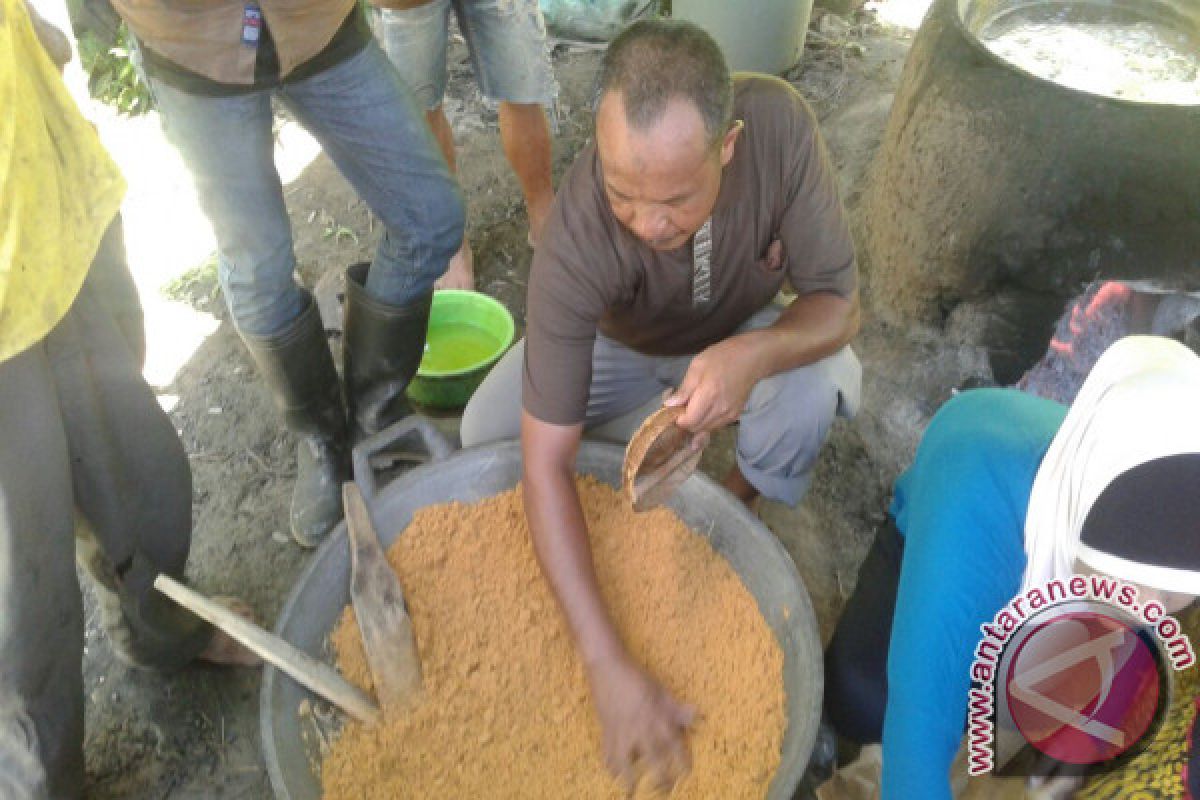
left=322, top=479, right=786, bottom=800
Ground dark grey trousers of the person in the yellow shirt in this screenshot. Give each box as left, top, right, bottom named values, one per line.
left=0, top=223, right=211, bottom=798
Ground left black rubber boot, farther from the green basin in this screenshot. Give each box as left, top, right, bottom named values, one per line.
left=242, top=296, right=349, bottom=547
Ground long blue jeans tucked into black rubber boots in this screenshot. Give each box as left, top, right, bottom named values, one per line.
left=151, top=42, right=466, bottom=336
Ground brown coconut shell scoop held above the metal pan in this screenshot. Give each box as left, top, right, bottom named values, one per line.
left=622, top=405, right=708, bottom=511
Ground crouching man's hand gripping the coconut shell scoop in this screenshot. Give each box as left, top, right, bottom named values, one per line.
left=664, top=333, right=766, bottom=433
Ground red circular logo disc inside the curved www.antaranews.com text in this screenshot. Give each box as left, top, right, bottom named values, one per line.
left=1004, top=612, right=1159, bottom=764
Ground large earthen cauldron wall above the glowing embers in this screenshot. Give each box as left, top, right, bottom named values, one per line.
left=862, top=0, right=1200, bottom=374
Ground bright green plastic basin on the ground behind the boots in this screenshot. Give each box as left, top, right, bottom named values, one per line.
left=408, top=289, right=516, bottom=409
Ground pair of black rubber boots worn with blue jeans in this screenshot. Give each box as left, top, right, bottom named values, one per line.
left=242, top=264, right=433, bottom=547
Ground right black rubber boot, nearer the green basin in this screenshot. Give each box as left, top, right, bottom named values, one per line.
left=342, top=264, right=433, bottom=440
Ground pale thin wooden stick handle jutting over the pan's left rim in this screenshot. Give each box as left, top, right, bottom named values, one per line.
left=154, top=575, right=379, bottom=724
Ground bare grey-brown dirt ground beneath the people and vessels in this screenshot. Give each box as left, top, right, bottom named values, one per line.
left=56, top=0, right=985, bottom=799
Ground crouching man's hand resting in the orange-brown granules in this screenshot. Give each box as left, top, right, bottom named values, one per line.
left=588, top=657, right=696, bottom=792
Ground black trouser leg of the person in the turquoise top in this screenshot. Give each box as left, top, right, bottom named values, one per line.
left=824, top=516, right=904, bottom=745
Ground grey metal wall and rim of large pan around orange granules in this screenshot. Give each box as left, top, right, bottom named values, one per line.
left=260, top=441, right=823, bottom=800
